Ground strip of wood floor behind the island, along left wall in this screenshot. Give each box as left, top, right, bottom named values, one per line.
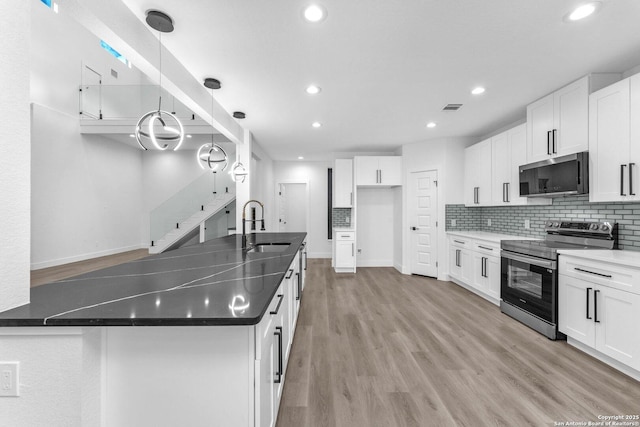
left=31, top=249, right=149, bottom=288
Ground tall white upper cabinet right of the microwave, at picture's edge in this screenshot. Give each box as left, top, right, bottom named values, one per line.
left=589, top=74, right=640, bottom=202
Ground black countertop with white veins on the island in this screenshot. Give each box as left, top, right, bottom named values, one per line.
left=0, top=233, right=306, bottom=326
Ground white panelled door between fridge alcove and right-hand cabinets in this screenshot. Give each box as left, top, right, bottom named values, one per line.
left=409, top=171, right=438, bottom=277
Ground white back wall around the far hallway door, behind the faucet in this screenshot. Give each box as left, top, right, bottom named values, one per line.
left=271, top=161, right=333, bottom=258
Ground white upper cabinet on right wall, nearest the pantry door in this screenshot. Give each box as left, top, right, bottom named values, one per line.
left=464, top=139, right=491, bottom=206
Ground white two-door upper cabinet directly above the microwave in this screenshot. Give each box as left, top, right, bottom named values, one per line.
left=527, top=74, right=619, bottom=163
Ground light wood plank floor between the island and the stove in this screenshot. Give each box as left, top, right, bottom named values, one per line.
left=277, top=259, right=640, bottom=427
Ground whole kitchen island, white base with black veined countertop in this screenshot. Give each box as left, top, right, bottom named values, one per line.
left=0, top=233, right=306, bottom=426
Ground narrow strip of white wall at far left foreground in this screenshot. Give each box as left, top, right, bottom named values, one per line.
left=0, top=1, right=33, bottom=310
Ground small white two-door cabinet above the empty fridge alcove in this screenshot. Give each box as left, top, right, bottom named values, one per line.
left=354, top=156, right=402, bottom=186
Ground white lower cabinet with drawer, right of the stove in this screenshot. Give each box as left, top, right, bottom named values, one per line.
left=558, top=255, right=640, bottom=371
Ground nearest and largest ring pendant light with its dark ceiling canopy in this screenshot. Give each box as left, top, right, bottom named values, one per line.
left=135, top=10, right=184, bottom=151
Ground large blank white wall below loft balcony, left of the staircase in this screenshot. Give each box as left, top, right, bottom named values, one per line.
left=31, top=104, right=142, bottom=269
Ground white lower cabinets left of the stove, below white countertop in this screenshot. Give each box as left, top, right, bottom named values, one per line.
left=449, top=235, right=501, bottom=305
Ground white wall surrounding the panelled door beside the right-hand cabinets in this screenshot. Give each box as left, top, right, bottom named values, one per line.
left=402, top=138, right=475, bottom=280
